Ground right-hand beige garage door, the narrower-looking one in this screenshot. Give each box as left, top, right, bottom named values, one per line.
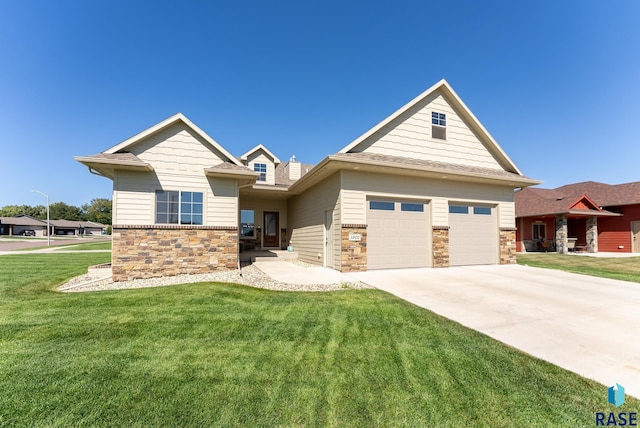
left=449, top=205, right=499, bottom=266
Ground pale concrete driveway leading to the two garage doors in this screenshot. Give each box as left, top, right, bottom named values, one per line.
left=350, top=265, right=640, bottom=397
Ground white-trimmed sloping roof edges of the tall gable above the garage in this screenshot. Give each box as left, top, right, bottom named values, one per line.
left=338, top=79, right=523, bottom=175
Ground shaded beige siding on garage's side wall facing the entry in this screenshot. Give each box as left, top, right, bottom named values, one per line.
left=288, top=173, right=341, bottom=269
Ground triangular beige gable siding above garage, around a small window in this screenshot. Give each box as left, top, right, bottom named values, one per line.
left=351, top=91, right=503, bottom=169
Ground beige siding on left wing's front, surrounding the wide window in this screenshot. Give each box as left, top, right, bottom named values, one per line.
left=113, top=124, right=238, bottom=227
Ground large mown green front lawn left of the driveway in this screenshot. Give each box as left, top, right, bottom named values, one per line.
left=0, top=253, right=640, bottom=427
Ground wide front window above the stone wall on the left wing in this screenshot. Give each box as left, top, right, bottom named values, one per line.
left=156, top=190, right=203, bottom=224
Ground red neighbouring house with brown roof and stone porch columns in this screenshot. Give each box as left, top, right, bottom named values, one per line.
left=515, top=181, right=640, bottom=253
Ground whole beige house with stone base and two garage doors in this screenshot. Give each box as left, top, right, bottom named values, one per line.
left=76, top=80, right=539, bottom=281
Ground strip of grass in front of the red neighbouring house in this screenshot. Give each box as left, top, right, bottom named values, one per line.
left=517, top=253, right=640, bottom=282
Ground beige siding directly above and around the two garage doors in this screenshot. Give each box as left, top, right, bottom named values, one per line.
left=341, top=171, right=515, bottom=227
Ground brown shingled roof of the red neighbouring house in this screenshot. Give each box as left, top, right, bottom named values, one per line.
left=515, top=181, right=640, bottom=217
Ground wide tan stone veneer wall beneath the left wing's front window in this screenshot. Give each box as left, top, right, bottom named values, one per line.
left=111, top=225, right=238, bottom=281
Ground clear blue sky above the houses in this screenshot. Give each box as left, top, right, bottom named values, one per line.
left=0, top=0, right=640, bottom=207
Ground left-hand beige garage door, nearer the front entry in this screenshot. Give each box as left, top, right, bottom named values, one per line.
left=367, top=199, right=431, bottom=269
